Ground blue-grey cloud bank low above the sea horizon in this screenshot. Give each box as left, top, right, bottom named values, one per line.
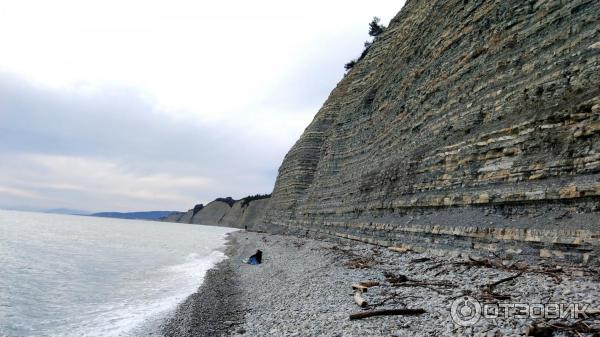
left=0, top=75, right=291, bottom=210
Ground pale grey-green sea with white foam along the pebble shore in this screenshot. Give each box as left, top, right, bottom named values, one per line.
left=0, top=211, right=237, bottom=337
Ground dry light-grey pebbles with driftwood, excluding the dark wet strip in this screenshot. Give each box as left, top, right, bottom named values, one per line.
left=228, top=232, right=600, bottom=337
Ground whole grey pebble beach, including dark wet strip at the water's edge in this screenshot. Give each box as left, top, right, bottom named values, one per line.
left=163, top=231, right=600, bottom=337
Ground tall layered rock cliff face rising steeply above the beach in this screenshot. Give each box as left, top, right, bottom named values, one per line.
left=259, top=0, right=600, bottom=260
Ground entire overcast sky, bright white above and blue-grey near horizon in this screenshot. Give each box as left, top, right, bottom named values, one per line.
left=0, top=0, right=404, bottom=211
